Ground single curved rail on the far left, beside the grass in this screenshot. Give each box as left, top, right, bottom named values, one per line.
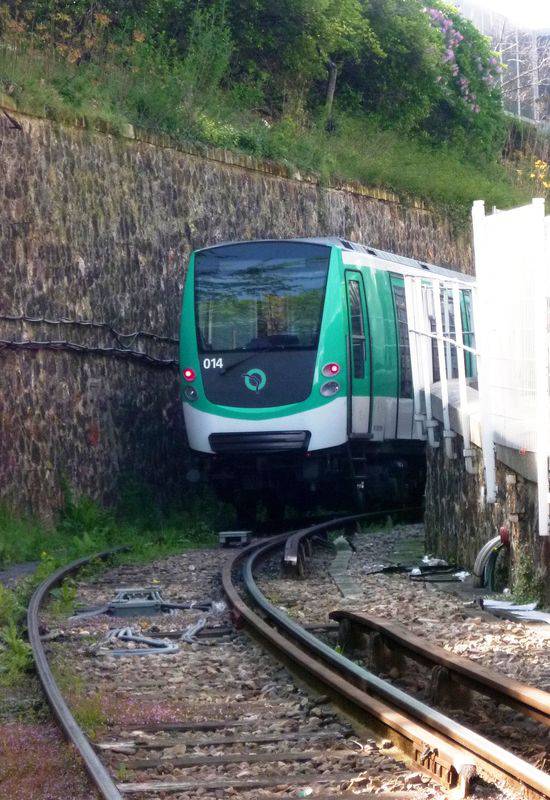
left=27, top=547, right=126, bottom=800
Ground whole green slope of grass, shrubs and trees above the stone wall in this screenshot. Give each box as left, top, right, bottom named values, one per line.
left=0, top=0, right=544, bottom=215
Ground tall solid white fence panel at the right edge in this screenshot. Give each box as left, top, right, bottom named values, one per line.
left=472, top=199, right=550, bottom=535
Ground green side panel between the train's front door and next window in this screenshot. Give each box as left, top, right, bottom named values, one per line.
left=361, top=267, right=399, bottom=397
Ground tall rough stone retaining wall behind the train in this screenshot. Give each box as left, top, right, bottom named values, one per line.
left=0, top=109, right=472, bottom=517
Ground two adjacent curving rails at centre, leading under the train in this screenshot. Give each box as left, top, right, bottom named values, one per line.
left=222, top=520, right=550, bottom=797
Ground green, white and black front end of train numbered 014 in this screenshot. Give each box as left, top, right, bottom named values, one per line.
left=180, top=241, right=347, bottom=479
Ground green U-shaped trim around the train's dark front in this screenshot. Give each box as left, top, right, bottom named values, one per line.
left=180, top=248, right=348, bottom=420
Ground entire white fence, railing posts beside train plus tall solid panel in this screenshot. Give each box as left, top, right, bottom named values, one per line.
left=396, top=199, right=550, bottom=536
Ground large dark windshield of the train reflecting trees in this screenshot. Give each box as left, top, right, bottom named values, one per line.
left=195, top=242, right=330, bottom=353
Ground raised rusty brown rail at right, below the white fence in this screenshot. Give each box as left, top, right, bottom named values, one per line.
left=329, top=610, right=550, bottom=727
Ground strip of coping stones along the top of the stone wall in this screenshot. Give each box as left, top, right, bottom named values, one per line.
left=0, top=98, right=437, bottom=214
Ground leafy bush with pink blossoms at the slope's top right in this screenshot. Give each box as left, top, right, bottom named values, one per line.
left=341, top=0, right=504, bottom=157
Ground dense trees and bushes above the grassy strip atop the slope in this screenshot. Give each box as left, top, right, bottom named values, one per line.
left=3, top=0, right=502, bottom=148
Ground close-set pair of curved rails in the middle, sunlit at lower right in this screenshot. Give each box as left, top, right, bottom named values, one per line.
left=222, top=520, right=550, bottom=797
